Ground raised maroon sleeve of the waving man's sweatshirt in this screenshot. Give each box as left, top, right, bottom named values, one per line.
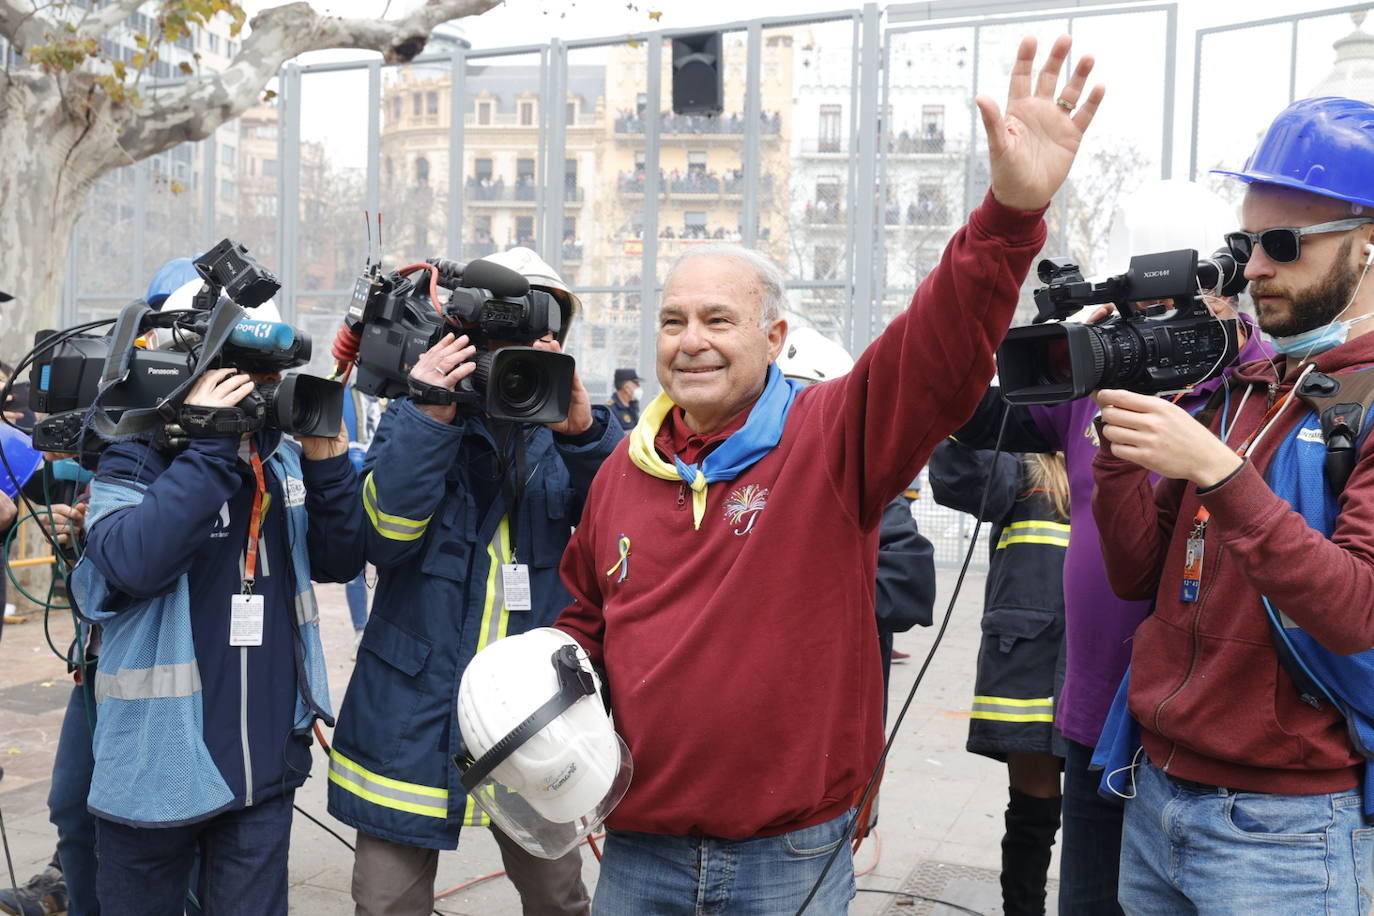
left=816, top=191, right=1046, bottom=530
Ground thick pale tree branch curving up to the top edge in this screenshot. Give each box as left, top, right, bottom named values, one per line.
left=114, top=0, right=500, bottom=161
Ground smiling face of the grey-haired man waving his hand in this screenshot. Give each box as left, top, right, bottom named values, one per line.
left=657, top=257, right=787, bottom=434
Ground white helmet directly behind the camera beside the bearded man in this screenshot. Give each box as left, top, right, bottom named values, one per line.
left=1102, top=179, right=1239, bottom=275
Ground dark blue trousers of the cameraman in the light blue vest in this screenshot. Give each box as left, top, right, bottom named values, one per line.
left=96, top=791, right=295, bottom=916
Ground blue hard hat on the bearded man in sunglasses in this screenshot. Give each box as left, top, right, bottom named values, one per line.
left=1212, top=96, right=1374, bottom=207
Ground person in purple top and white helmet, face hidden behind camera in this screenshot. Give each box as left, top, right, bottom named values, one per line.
left=954, top=181, right=1268, bottom=913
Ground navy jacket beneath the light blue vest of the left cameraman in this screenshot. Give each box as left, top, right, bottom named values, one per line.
left=82, top=431, right=363, bottom=820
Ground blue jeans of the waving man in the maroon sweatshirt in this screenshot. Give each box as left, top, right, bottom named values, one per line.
left=592, top=812, right=855, bottom=916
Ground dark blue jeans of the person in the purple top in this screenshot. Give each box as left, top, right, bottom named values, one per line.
left=1059, top=740, right=1123, bottom=916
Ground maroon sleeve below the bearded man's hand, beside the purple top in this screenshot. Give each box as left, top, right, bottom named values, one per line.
left=1092, top=450, right=1184, bottom=600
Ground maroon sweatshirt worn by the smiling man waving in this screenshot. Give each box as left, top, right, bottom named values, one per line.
left=556, top=194, right=1044, bottom=839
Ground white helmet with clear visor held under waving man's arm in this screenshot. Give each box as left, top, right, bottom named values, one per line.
left=458, top=626, right=633, bottom=858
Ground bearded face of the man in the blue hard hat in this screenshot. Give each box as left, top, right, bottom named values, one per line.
left=1241, top=184, right=1370, bottom=336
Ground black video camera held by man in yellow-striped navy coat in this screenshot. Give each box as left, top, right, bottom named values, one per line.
left=346, top=258, right=576, bottom=423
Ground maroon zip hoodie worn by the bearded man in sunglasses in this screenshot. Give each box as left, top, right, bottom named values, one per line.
left=1092, top=334, right=1374, bottom=795
